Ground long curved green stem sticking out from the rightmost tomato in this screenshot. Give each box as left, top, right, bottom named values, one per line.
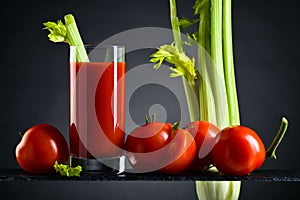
left=266, top=117, right=288, bottom=160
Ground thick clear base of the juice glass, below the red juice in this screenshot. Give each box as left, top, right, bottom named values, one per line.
left=72, top=156, right=125, bottom=173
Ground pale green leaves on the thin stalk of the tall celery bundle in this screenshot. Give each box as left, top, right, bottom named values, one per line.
left=150, top=44, right=197, bottom=84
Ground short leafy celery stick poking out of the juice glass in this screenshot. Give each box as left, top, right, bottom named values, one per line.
left=43, top=14, right=89, bottom=62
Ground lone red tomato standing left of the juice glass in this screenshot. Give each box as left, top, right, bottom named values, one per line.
left=15, top=124, right=69, bottom=174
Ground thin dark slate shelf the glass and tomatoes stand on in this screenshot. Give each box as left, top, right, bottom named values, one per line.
left=0, top=169, right=300, bottom=182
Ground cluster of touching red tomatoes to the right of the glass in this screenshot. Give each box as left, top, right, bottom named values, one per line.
left=125, top=121, right=266, bottom=176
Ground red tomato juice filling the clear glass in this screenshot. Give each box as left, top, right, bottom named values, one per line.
left=69, top=62, right=125, bottom=158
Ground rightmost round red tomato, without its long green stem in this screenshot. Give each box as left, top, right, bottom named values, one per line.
left=212, top=126, right=266, bottom=176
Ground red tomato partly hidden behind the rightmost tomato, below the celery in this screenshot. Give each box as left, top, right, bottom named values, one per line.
left=186, top=121, right=220, bottom=170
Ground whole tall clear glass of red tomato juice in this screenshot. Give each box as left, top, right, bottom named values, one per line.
left=69, top=45, right=126, bottom=172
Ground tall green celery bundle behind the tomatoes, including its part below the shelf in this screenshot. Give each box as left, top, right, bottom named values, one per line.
left=150, top=0, right=241, bottom=199
